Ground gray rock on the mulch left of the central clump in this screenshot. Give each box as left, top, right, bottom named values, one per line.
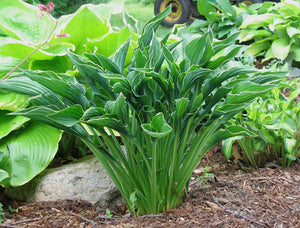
left=5, top=156, right=121, bottom=206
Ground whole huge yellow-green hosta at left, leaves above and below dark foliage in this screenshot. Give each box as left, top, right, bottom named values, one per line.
left=0, top=0, right=136, bottom=187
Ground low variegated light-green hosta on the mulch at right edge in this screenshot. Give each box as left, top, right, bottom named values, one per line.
left=223, top=79, right=300, bottom=168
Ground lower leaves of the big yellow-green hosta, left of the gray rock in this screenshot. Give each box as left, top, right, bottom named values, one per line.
left=0, top=92, right=62, bottom=187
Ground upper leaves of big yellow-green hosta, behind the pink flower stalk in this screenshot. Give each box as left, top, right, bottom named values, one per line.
left=0, top=0, right=135, bottom=78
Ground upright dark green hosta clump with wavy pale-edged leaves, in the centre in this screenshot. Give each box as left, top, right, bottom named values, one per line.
left=0, top=8, right=280, bottom=214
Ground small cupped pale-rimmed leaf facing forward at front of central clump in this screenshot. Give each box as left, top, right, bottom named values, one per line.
left=141, top=113, right=172, bottom=138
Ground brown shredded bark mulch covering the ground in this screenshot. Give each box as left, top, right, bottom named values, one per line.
left=0, top=146, right=300, bottom=228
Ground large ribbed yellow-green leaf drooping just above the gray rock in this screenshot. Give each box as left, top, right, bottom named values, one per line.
left=0, top=123, right=62, bottom=187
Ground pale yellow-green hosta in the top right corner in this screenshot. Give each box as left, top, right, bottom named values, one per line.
left=239, top=0, right=300, bottom=63
